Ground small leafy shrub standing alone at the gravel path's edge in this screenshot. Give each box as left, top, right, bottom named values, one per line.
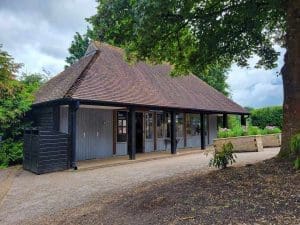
left=209, top=142, right=236, bottom=169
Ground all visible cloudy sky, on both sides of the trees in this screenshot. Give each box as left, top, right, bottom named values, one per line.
left=0, top=0, right=284, bottom=108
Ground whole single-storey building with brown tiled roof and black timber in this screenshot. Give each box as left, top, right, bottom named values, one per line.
left=24, top=42, right=248, bottom=174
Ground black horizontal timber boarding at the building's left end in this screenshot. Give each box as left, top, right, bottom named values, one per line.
left=23, top=107, right=70, bottom=174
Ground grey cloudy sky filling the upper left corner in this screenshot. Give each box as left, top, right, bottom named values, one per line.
left=0, top=0, right=96, bottom=75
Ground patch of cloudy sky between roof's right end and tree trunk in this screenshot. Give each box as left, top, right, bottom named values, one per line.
left=227, top=47, right=284, bottom=107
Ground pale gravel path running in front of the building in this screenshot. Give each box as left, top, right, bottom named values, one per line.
left=0, top=148, right=279, bottom=224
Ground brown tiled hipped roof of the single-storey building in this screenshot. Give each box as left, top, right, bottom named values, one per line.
left=36, top=43, right=247, bottom=113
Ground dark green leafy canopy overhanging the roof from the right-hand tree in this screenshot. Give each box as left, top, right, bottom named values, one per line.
left=88, top=0, right=285, bottom=74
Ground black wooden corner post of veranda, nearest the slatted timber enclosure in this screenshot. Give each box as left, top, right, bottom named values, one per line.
left=68, top=101, right=80, bottom=170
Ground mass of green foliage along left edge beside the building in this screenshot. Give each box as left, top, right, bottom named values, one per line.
left=0, top=46, right=44, bottom=167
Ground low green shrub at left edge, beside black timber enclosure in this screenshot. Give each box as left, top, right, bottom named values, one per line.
left=0, top=138, right=23, bottom=168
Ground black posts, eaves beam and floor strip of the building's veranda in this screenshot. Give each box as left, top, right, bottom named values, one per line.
left=62, top=99, right=247, bottom=169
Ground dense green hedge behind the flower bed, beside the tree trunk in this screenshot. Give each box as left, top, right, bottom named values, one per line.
left=250, top=106, right=283, bottom=129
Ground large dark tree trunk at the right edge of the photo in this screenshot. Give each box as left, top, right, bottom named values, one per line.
left=279, top=0, right=300, bottom=158
